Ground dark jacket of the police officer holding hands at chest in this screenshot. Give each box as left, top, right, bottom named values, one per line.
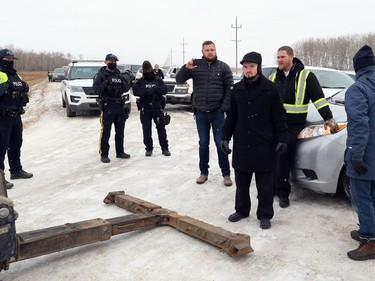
left=133, top=74, right=168, bottom=108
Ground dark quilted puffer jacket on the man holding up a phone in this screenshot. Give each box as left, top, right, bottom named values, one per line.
left=176, top=59, right=233, bottom=112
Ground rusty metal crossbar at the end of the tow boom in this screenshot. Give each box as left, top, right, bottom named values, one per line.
left=104, top=191, right=254, bottom=257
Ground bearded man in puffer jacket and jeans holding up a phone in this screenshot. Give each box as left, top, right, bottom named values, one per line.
left=176, top=41, right=233, bottom=186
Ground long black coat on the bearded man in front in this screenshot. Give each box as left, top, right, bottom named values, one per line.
left=222, top=75, right=288, bottom=172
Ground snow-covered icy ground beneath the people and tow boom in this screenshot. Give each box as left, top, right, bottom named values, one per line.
left=0, top=82, right=375, bottom=281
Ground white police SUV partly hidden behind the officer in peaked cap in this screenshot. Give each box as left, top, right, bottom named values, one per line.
left=60, top=60, right=131, bottom=117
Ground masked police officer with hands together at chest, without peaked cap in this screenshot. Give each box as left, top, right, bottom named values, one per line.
left=133, top=60, right=171, bottom=156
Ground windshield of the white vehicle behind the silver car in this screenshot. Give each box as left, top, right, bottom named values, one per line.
left=311, top=69, right=354, bottom=89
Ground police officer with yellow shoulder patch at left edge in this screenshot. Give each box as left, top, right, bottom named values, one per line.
left=0, top=49, right=33, bottom=188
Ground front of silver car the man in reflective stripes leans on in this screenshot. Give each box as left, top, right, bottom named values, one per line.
left=291, top=89, right=350, bottom=198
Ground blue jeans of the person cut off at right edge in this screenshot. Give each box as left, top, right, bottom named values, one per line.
left=350, top=178, right=375, bottom=238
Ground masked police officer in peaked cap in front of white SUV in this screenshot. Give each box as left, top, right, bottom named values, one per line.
left=93, top=54, right=130, bottom=163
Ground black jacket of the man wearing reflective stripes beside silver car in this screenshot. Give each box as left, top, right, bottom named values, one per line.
left=274, top=58, right=332, bottom=129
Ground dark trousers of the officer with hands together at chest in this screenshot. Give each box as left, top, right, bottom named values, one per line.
left=140, top=107, right=168, bottom=151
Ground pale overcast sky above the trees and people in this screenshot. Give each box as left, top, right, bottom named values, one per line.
left=4, top=0, right=375, bottom=67
